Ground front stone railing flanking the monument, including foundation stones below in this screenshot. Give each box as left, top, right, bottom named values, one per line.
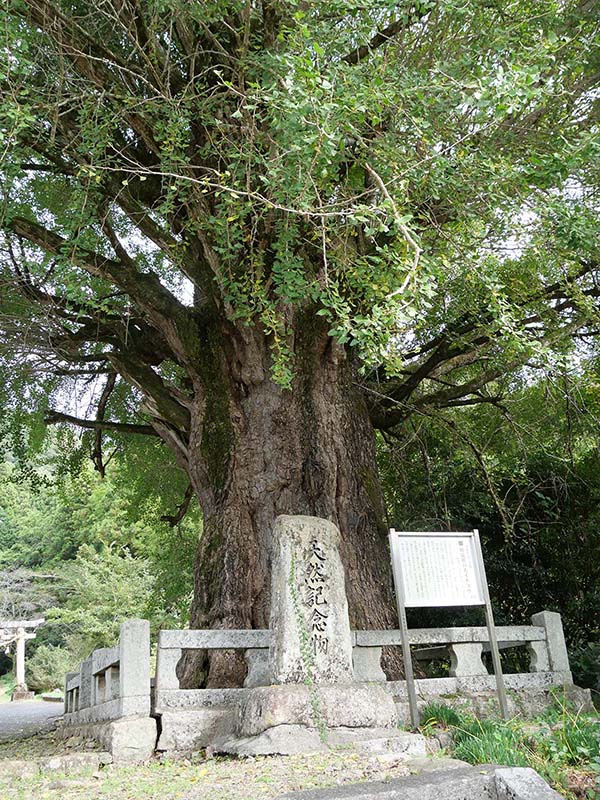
left=149, top=611, right=572, bottom=753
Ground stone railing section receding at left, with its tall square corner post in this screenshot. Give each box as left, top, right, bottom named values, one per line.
left=63, top=619, right=150, bottom=726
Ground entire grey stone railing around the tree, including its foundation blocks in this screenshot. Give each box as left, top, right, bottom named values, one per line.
left=63, top=611, right=572, bottom=760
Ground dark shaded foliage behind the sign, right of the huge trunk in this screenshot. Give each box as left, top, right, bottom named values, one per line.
left=380, top=368, right=600, bottom=689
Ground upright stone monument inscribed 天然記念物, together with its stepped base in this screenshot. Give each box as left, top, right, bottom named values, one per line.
left=216, top=516, right=422, bottom=755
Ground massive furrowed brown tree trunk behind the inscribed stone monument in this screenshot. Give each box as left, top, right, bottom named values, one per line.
left=183, top=318, right=395, bottom=685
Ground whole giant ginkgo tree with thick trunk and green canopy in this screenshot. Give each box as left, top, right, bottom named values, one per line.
left=0, top=0, right=600, bottom=682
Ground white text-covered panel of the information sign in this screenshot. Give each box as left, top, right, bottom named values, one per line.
left=390, top=531, right=485, bottom=608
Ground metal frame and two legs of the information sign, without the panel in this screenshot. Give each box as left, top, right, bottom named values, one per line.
left=388, top=528, right=509, bottom=728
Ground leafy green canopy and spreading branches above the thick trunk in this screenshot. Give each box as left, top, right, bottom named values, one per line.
left=0, top=0, right=600, bottom=424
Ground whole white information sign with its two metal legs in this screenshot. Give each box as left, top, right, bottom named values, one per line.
left=389, top=528, right=508, bottom=727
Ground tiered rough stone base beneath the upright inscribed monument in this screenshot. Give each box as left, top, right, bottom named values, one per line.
left=212, top=683, right=426, bottom=756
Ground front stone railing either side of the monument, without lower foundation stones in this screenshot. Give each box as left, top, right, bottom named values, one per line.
left=155, top=611, right=573, bottom=713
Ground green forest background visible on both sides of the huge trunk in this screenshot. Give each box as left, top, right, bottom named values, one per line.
left=0, top=368, right=600, bottom=691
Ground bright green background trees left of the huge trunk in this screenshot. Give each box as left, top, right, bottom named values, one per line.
left=0, top=449, right=200, bottom=689
